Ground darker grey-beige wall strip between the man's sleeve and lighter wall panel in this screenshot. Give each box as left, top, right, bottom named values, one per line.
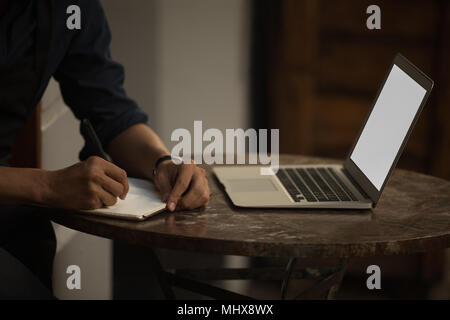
left=101, top=0, right=159, bottom=127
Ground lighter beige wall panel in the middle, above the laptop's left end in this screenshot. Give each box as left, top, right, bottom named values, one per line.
left=156, top=0, right=249, bottom=143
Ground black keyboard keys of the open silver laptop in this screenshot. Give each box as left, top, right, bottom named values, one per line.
left=277, top=168, right=358, bottom=202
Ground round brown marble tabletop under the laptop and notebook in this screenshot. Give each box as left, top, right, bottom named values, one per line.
left=47, top=155, right=450, bottom=258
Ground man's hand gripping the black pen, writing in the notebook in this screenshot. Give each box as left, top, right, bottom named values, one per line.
left=44, top=157, right=129, bottom=210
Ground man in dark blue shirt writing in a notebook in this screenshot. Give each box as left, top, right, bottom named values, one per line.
left=0, top=0, right=209, bottom=298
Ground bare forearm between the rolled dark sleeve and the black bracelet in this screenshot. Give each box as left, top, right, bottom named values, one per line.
left=107, top=124, right=170, bottom=179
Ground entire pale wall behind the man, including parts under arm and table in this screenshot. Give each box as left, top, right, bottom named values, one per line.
left=42, top=0, right=249, bottom=299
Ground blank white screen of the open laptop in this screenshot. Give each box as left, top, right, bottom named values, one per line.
left=350, top=65, right=426, bottom=190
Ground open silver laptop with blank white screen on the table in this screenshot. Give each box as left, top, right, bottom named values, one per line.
left=213, top=54, right=434, bottom=209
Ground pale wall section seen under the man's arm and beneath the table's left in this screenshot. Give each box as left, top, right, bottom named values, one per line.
left=41, top=81, right=112, bottom=299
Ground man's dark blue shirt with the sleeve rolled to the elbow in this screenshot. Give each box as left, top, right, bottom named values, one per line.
left=0, top=0, right=148, bottom=155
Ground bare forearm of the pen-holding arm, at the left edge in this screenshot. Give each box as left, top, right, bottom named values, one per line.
left=0, top=167, right=48, bottom=204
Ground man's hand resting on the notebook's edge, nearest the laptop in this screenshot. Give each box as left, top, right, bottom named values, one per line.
left=155, top=160, right=209, bottom=211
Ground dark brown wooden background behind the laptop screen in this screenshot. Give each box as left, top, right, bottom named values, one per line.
left=252, top=0, right=450, bottom=179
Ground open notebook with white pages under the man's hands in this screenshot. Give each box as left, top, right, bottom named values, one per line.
left=84, top=178, right=166, bottom=220
